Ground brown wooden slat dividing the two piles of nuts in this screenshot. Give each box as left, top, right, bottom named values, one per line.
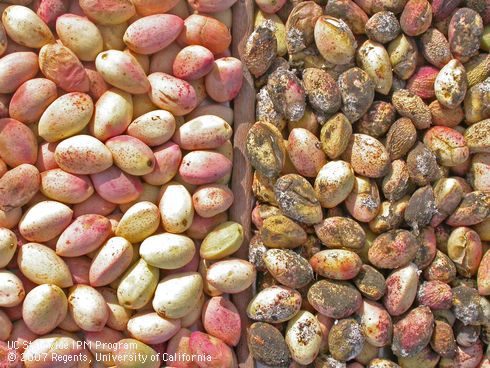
left=230, top=0, right=255, bottom=368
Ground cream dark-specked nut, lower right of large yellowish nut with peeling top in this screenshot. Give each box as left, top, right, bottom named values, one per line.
left=357, top=40, right=393, bottom=95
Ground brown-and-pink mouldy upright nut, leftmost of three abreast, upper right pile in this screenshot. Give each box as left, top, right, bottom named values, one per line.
left=267, top=68, right=306, bottom=120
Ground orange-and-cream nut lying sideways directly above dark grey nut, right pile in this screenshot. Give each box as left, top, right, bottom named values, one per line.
left=310, top=249, right=362, bottom=280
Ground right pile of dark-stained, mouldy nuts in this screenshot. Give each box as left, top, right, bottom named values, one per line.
left=241, top=0, right=490, bottom=368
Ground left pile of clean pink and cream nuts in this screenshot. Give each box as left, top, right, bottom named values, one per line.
left=0, top=0, right=255, bottom=368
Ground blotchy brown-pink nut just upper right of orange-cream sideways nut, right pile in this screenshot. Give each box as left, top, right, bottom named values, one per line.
left=368, top=229, right=419, bottom=269
